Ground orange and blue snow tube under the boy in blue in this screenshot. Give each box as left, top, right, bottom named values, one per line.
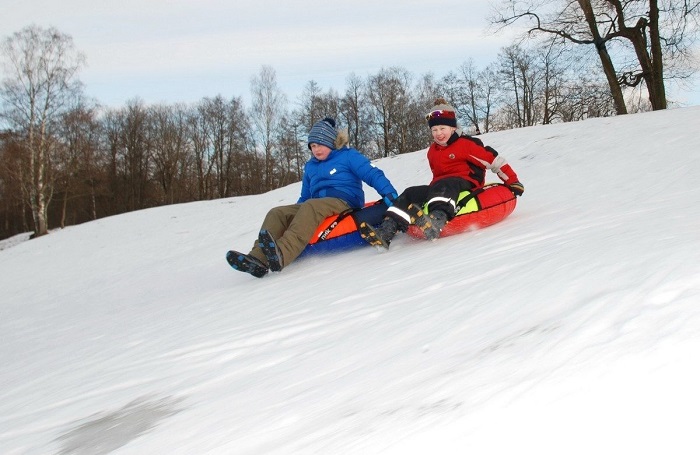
left=301, top=201, right=387, bottom=255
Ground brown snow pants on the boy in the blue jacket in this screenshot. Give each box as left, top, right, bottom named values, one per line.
left=250, top=197, right=350, bottom=267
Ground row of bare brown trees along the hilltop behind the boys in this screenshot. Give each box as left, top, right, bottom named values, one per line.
left=0, top=36, right=646, bottom=238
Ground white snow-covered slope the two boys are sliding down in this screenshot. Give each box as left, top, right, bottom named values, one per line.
left=0, top=107, right=700, bottom=455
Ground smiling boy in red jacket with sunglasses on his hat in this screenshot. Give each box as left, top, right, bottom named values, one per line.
left=360, top=98, right=525, bottom=248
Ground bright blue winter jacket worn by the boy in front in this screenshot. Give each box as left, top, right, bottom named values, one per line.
left=297, top=147, right=396, bottom=208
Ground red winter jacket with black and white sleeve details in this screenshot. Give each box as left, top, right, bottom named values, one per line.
left=428, top=133, right=518, bottom=189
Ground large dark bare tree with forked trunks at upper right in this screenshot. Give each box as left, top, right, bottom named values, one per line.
left=493, top=0, right=700, bottom=114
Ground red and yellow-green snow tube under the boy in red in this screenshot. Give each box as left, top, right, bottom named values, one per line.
left=408, top=183, right=516, bottom=239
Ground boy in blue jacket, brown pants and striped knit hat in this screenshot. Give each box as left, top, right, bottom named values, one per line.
left=226, top=117, right=397, bottom=278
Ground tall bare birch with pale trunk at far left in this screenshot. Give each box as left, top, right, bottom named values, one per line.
left=0, top=26, right=85, bottom=236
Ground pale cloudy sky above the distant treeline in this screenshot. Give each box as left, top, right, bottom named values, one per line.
left=0, top=0, right=700, bottom=107
